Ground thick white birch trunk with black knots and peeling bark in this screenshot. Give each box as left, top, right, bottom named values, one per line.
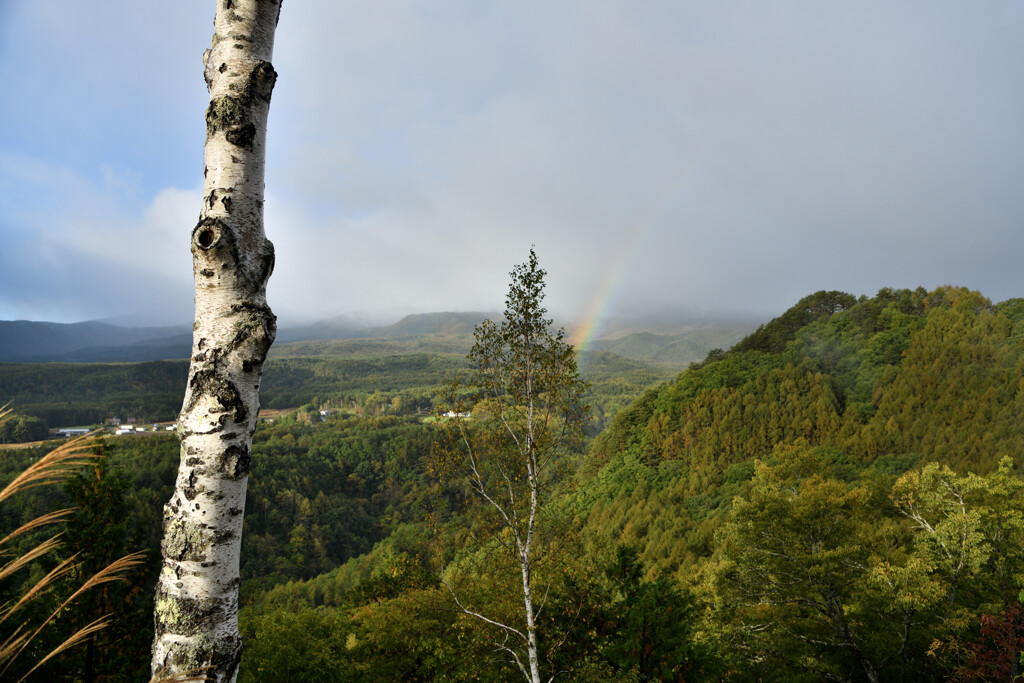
left=152, top=0, right=281, bottom=681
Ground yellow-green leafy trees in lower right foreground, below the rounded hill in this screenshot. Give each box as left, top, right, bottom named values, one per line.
left=703, top=447, right=1024, bottom=680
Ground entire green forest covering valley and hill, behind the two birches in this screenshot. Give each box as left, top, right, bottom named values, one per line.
left=0, top=287, right=1024, bottom=681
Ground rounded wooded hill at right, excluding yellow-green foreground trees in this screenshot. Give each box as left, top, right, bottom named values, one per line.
left=582, top=288, right=1024, bottom=577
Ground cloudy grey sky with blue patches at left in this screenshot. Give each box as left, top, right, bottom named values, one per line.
left=0, top=0, right=1024, bottom=323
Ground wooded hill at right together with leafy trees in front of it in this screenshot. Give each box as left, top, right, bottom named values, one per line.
left=572, top=288, right=1024, bottom=680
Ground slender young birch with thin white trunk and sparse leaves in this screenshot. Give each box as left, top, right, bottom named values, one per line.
left=435, top=249, right=586, bottom=683
